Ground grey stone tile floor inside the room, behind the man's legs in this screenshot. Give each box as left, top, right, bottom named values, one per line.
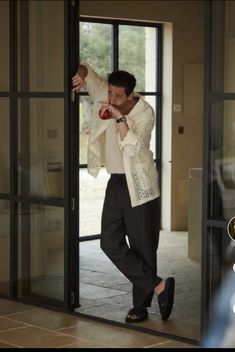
left=76, top=231, right=201, bottom=341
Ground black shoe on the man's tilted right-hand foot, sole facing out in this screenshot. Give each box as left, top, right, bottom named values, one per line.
left=158, top=277, right=175, bottom=321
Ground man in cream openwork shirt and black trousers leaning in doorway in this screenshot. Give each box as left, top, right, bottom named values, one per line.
left=72, top=64, right=175, bottom=323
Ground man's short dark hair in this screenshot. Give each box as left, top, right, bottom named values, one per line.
left=108, top=70, right=136, bottom=96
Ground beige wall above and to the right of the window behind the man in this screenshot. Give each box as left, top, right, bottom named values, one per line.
left=80, top=0, right=204, bottom=230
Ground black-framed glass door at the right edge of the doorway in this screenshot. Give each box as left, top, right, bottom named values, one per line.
left=202, top=1, right=235, bottom=331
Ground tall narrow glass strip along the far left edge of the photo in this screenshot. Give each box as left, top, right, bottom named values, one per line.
left=0, top=1, right=11, bottom=296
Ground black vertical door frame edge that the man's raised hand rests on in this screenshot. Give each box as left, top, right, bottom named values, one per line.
left=67, top=0, right=80, bottom=312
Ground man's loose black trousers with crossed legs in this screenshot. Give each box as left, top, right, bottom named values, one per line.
left=100, top=174, right=162, bottom=308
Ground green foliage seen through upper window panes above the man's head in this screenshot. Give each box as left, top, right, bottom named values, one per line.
left=80, top=22, right=145, bottom=91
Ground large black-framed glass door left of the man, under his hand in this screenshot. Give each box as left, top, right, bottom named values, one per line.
left=0, top=0, right=78, bottom=309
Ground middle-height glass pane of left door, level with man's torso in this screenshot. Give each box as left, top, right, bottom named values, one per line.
left=19, top=98, right=64, bottom=198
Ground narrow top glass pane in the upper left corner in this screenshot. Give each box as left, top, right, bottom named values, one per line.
left=0, top=1, right=10, bottom=91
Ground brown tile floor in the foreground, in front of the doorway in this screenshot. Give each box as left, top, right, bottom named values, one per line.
left=0, top=298, right=197, bottom=348
